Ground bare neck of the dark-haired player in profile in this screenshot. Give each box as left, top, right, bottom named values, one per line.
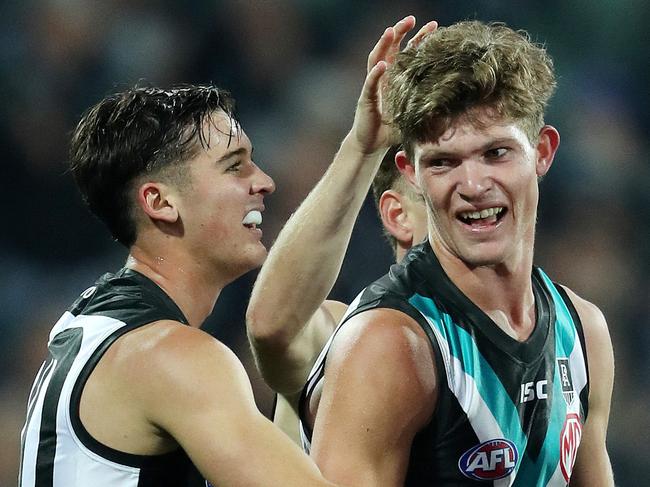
left=126, top=242, right=227, bottom=328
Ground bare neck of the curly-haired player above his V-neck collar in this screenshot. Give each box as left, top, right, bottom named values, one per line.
left=432, top=239, right=535, bottom=340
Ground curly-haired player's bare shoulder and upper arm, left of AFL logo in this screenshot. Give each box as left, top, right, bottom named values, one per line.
left=311, top=309, right=438, bottom=487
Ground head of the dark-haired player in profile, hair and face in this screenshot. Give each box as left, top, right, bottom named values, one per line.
left=70, top=86, right=274, bottom=277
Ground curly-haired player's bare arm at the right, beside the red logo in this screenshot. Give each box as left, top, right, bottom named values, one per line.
left=567, top=289, right=614, bottom=487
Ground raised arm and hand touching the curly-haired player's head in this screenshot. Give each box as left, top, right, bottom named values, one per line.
left=247, top=16, right=436, bottom=393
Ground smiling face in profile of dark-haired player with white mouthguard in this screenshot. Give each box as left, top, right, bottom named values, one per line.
left=172, top=112, right=275, bottom=278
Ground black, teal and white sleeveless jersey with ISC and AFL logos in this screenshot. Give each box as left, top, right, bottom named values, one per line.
left=301, top=243, right=589, bottom=487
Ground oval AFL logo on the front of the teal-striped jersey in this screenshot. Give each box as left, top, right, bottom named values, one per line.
left=458, top=438, right=519, bottom=480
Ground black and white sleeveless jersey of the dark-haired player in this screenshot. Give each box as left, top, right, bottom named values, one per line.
left=19, top=269, right=195, bottom=487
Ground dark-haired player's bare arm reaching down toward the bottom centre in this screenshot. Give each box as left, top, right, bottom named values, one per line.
left=137, top=326, right=340, bottom=487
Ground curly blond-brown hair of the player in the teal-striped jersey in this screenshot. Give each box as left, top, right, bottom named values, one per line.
left=386, top=21, right=556, bottom=156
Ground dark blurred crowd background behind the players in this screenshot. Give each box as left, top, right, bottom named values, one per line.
left=0, top=0, right=650, bottom=486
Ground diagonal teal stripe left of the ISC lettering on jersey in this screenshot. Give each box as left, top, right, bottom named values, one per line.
left=409, top=294, right=528, bottom=471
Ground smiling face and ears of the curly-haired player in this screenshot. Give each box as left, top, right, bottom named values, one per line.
left=397, top=108, right=559, bottom=266
